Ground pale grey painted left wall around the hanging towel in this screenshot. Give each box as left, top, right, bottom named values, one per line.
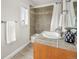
left=1, top=0, right=29, bottom=59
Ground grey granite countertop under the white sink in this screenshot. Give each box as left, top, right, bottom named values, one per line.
left=31, top=36, right=77, bottom=52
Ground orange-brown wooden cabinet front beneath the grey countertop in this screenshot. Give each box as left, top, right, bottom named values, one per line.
left=33, top=43, right=77, bottom=59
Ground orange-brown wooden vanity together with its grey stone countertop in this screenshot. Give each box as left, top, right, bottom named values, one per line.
left=32, top=35, right=77, bottom=59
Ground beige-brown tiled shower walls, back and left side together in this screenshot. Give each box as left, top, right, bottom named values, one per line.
left=30, top=6, right=53, bottom=35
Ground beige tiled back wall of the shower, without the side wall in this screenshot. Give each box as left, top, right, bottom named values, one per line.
left=35, top=6, right=53, bottom=33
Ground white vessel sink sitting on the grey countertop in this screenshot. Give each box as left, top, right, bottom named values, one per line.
left=40, top=31, right=61, bottom=39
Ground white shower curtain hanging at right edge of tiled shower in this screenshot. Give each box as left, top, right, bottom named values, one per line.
left=50, top=4, right=61, bottom=31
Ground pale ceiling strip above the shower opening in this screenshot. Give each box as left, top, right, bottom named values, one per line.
left=29, top=0, right=61, bottom=5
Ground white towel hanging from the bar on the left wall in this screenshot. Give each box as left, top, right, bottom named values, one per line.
left=6, top=21, right=16, bottom=44
